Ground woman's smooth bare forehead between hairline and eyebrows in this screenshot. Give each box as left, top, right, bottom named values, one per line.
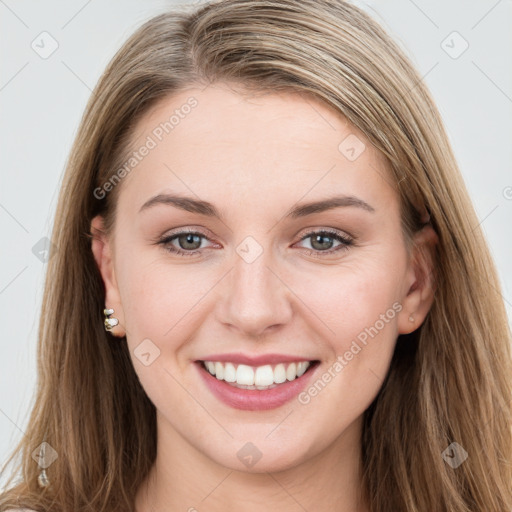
left=115, top=83, right=397, bottom=212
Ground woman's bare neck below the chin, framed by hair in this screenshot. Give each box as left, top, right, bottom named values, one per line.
left=135, top=414, right=368, bottom=512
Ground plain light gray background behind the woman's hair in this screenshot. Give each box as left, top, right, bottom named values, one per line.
left=0, top=0, right=512, bottom=480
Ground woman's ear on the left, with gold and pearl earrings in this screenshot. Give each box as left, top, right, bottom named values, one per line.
left=91, top=215, right=126, bottom=338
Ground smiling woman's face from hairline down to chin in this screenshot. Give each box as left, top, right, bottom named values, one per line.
left=93, top=84, right=429, bottom=471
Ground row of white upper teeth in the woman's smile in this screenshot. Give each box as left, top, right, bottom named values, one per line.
left=204, top=361, right=311, bottom=389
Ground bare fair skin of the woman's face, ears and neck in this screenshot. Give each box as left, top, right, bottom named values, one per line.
left=91, top=84, right=436, bottom=512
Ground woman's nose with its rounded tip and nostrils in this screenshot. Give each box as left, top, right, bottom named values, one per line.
left=217, top=246, right=293, bottom=338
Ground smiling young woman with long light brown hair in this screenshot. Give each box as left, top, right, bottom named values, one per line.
left=0, top=0, right=512, bottom=512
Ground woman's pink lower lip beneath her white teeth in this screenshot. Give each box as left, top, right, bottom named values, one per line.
left=195, top=361, right=319, bottom=411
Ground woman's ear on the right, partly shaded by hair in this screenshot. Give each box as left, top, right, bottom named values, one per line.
left=398, top=224, right=439, bottom=334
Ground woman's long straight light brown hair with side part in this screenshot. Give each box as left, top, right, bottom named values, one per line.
left=0, top=0, right=512, bottom=512
